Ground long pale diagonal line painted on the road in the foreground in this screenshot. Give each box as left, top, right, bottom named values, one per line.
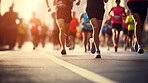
left=39, top=52, right=117, bottom=83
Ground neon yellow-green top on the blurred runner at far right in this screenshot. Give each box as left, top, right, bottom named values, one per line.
left=126, top=15, right=135, bottom=31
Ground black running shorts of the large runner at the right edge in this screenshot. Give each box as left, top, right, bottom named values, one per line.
left=127, top=1, right=148, bottom=20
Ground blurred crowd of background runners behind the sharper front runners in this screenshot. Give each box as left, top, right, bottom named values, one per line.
left=0, top=0, right=148, bottom=52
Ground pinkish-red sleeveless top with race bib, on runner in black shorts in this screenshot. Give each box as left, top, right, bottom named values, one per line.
left=111, top=6, right=123, bottom=24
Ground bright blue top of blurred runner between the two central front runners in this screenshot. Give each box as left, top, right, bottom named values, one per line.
left=83, top=13, right=93, bottom=30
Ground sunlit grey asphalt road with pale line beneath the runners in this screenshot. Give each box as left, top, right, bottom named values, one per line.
left=0, top=42, right=148, bottom=83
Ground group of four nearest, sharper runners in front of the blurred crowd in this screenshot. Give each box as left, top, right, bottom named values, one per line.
left=46, top=0, right=148, bottom=58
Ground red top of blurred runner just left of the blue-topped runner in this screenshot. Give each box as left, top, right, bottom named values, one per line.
left=69, top=18, right=79, bottom=33
